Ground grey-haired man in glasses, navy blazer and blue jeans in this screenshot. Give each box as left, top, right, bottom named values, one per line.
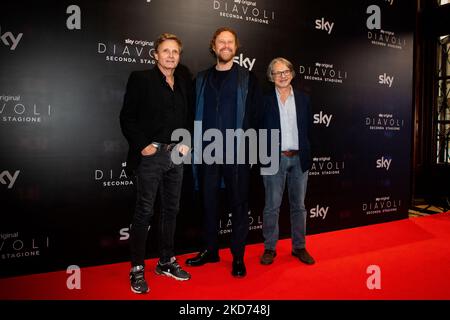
left=260, top=58, right=315, bottom=265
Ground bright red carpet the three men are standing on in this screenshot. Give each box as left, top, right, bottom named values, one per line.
left=0, top=212, right=450, bottom=300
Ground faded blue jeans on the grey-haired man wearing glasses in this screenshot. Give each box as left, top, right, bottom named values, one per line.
left=263, top=155, right=308, bottom=250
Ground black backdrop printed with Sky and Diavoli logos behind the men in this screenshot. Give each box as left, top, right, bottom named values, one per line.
left=0, top=0, right=415, bottom=277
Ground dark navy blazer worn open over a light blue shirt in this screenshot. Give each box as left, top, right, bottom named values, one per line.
left=259, top=87, right=312, bottom=172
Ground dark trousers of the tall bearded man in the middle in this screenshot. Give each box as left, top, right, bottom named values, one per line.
left=200, top=164, right=250, bottom=259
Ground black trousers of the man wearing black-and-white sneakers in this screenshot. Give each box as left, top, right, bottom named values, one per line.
left=130, top=150, right=183, bottom=266
